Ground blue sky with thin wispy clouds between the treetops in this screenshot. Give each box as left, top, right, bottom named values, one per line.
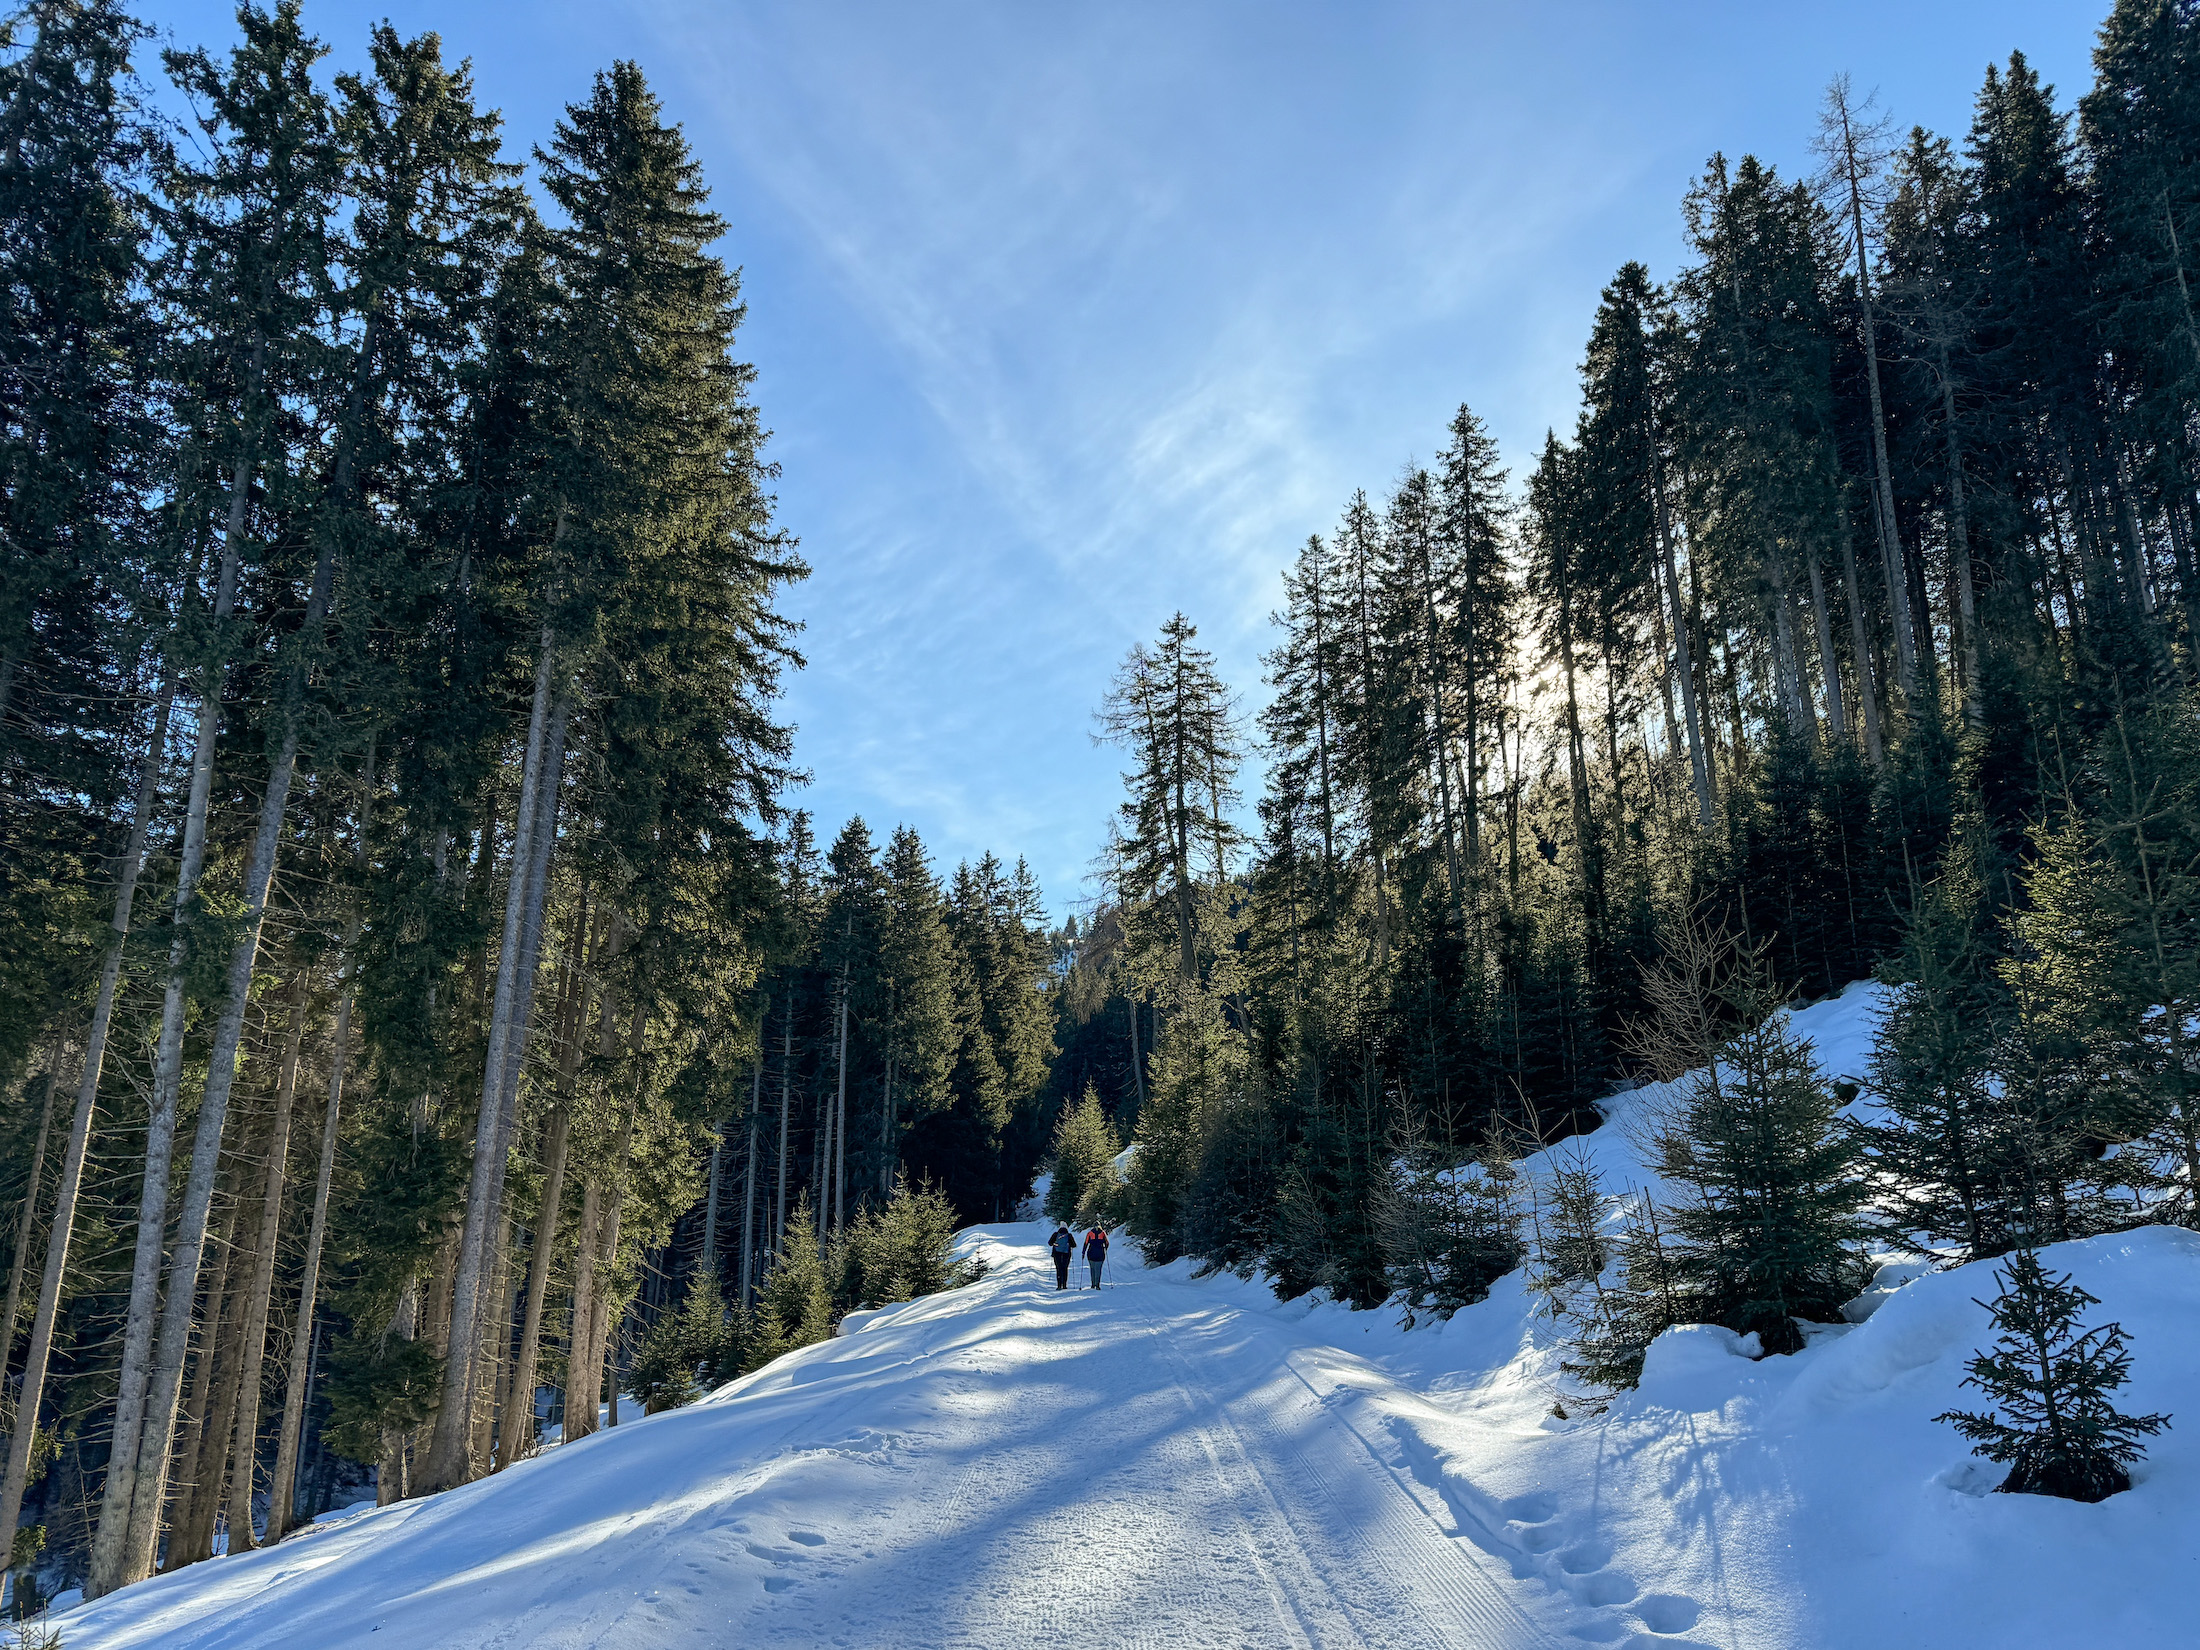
left=147, top=0, right=2105, bottom=913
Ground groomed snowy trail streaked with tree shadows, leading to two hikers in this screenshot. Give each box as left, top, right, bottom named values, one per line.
left=64, top=1228, right=1551, bottom=1650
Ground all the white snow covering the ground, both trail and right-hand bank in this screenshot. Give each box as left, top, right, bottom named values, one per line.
left=55, top=986, right=2200, bottom=1650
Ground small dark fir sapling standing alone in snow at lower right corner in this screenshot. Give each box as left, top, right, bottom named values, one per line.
left=1934, top=1250, right=2169, bottom=1500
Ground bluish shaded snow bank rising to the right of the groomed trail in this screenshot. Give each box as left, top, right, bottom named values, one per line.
left=1157, top=983, right=2200, bottom=1650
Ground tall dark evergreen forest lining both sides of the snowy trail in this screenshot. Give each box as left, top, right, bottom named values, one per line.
left=0, top=0, right=2200, bottom=1608
